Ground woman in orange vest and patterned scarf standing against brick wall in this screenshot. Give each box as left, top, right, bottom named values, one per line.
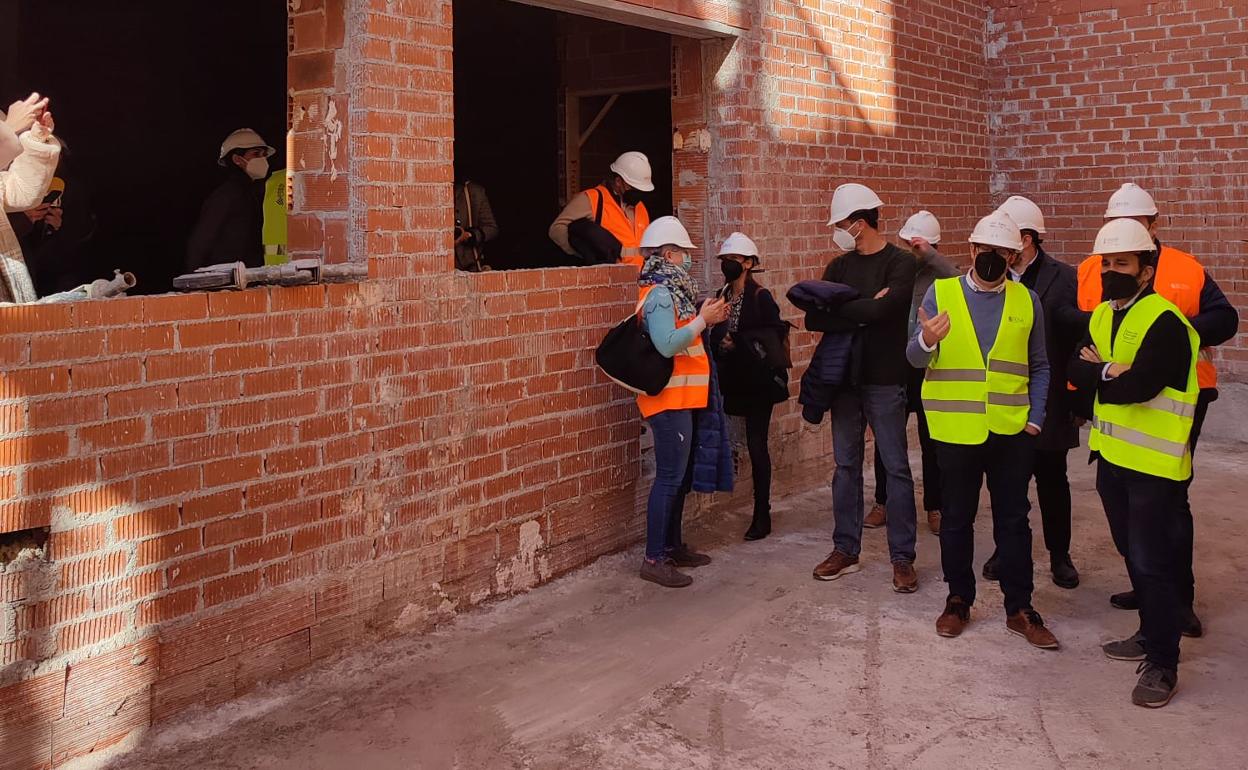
left=636, top=217, right=729, bottom=588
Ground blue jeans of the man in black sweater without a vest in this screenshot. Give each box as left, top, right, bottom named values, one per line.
left=832, top=384, right=917, bottom=564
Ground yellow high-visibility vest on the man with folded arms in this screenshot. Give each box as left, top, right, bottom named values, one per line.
left=1088, top=295, right=1201, bottom=482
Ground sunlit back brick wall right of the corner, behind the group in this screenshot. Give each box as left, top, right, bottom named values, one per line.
left=988, top=0, right=1248, bottom=382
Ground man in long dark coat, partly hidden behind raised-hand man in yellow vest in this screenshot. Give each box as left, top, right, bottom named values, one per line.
left=983, top=195, right=1087, bottom=589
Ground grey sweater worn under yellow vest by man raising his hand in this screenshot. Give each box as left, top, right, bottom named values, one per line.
left=906, top=275, right=1048, bottom=428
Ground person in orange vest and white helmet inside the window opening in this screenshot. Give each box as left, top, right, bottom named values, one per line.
left=549, top=152, right=654, bottom=270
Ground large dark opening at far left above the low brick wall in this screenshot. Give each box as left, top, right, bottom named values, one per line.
left=0, top=0, right=287, bottom=293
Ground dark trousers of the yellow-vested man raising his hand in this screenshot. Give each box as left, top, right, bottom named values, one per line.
left=936, top=433, right=1036, bottom=615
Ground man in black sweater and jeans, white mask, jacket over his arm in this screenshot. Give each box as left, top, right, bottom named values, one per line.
left=806, top=185, right=919, bottom=593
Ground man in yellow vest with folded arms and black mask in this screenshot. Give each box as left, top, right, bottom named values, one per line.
left=1070, top=218, right=1201, bottom=708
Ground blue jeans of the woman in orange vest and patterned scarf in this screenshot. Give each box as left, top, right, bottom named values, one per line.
left=645, top=409, right=694, bottom=559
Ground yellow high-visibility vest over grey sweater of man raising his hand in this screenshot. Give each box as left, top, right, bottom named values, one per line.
left=922, top=277, right=1036, bottom=444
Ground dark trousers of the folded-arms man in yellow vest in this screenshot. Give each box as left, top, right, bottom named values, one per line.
left=1096, top=458, right=1187, bottom=668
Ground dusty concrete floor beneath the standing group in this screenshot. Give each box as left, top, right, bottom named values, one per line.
left=90, top=444, right=1248, bottom=770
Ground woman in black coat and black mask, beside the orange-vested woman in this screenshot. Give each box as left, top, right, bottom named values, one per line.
left=710, top=232, right=790, bottom=540
